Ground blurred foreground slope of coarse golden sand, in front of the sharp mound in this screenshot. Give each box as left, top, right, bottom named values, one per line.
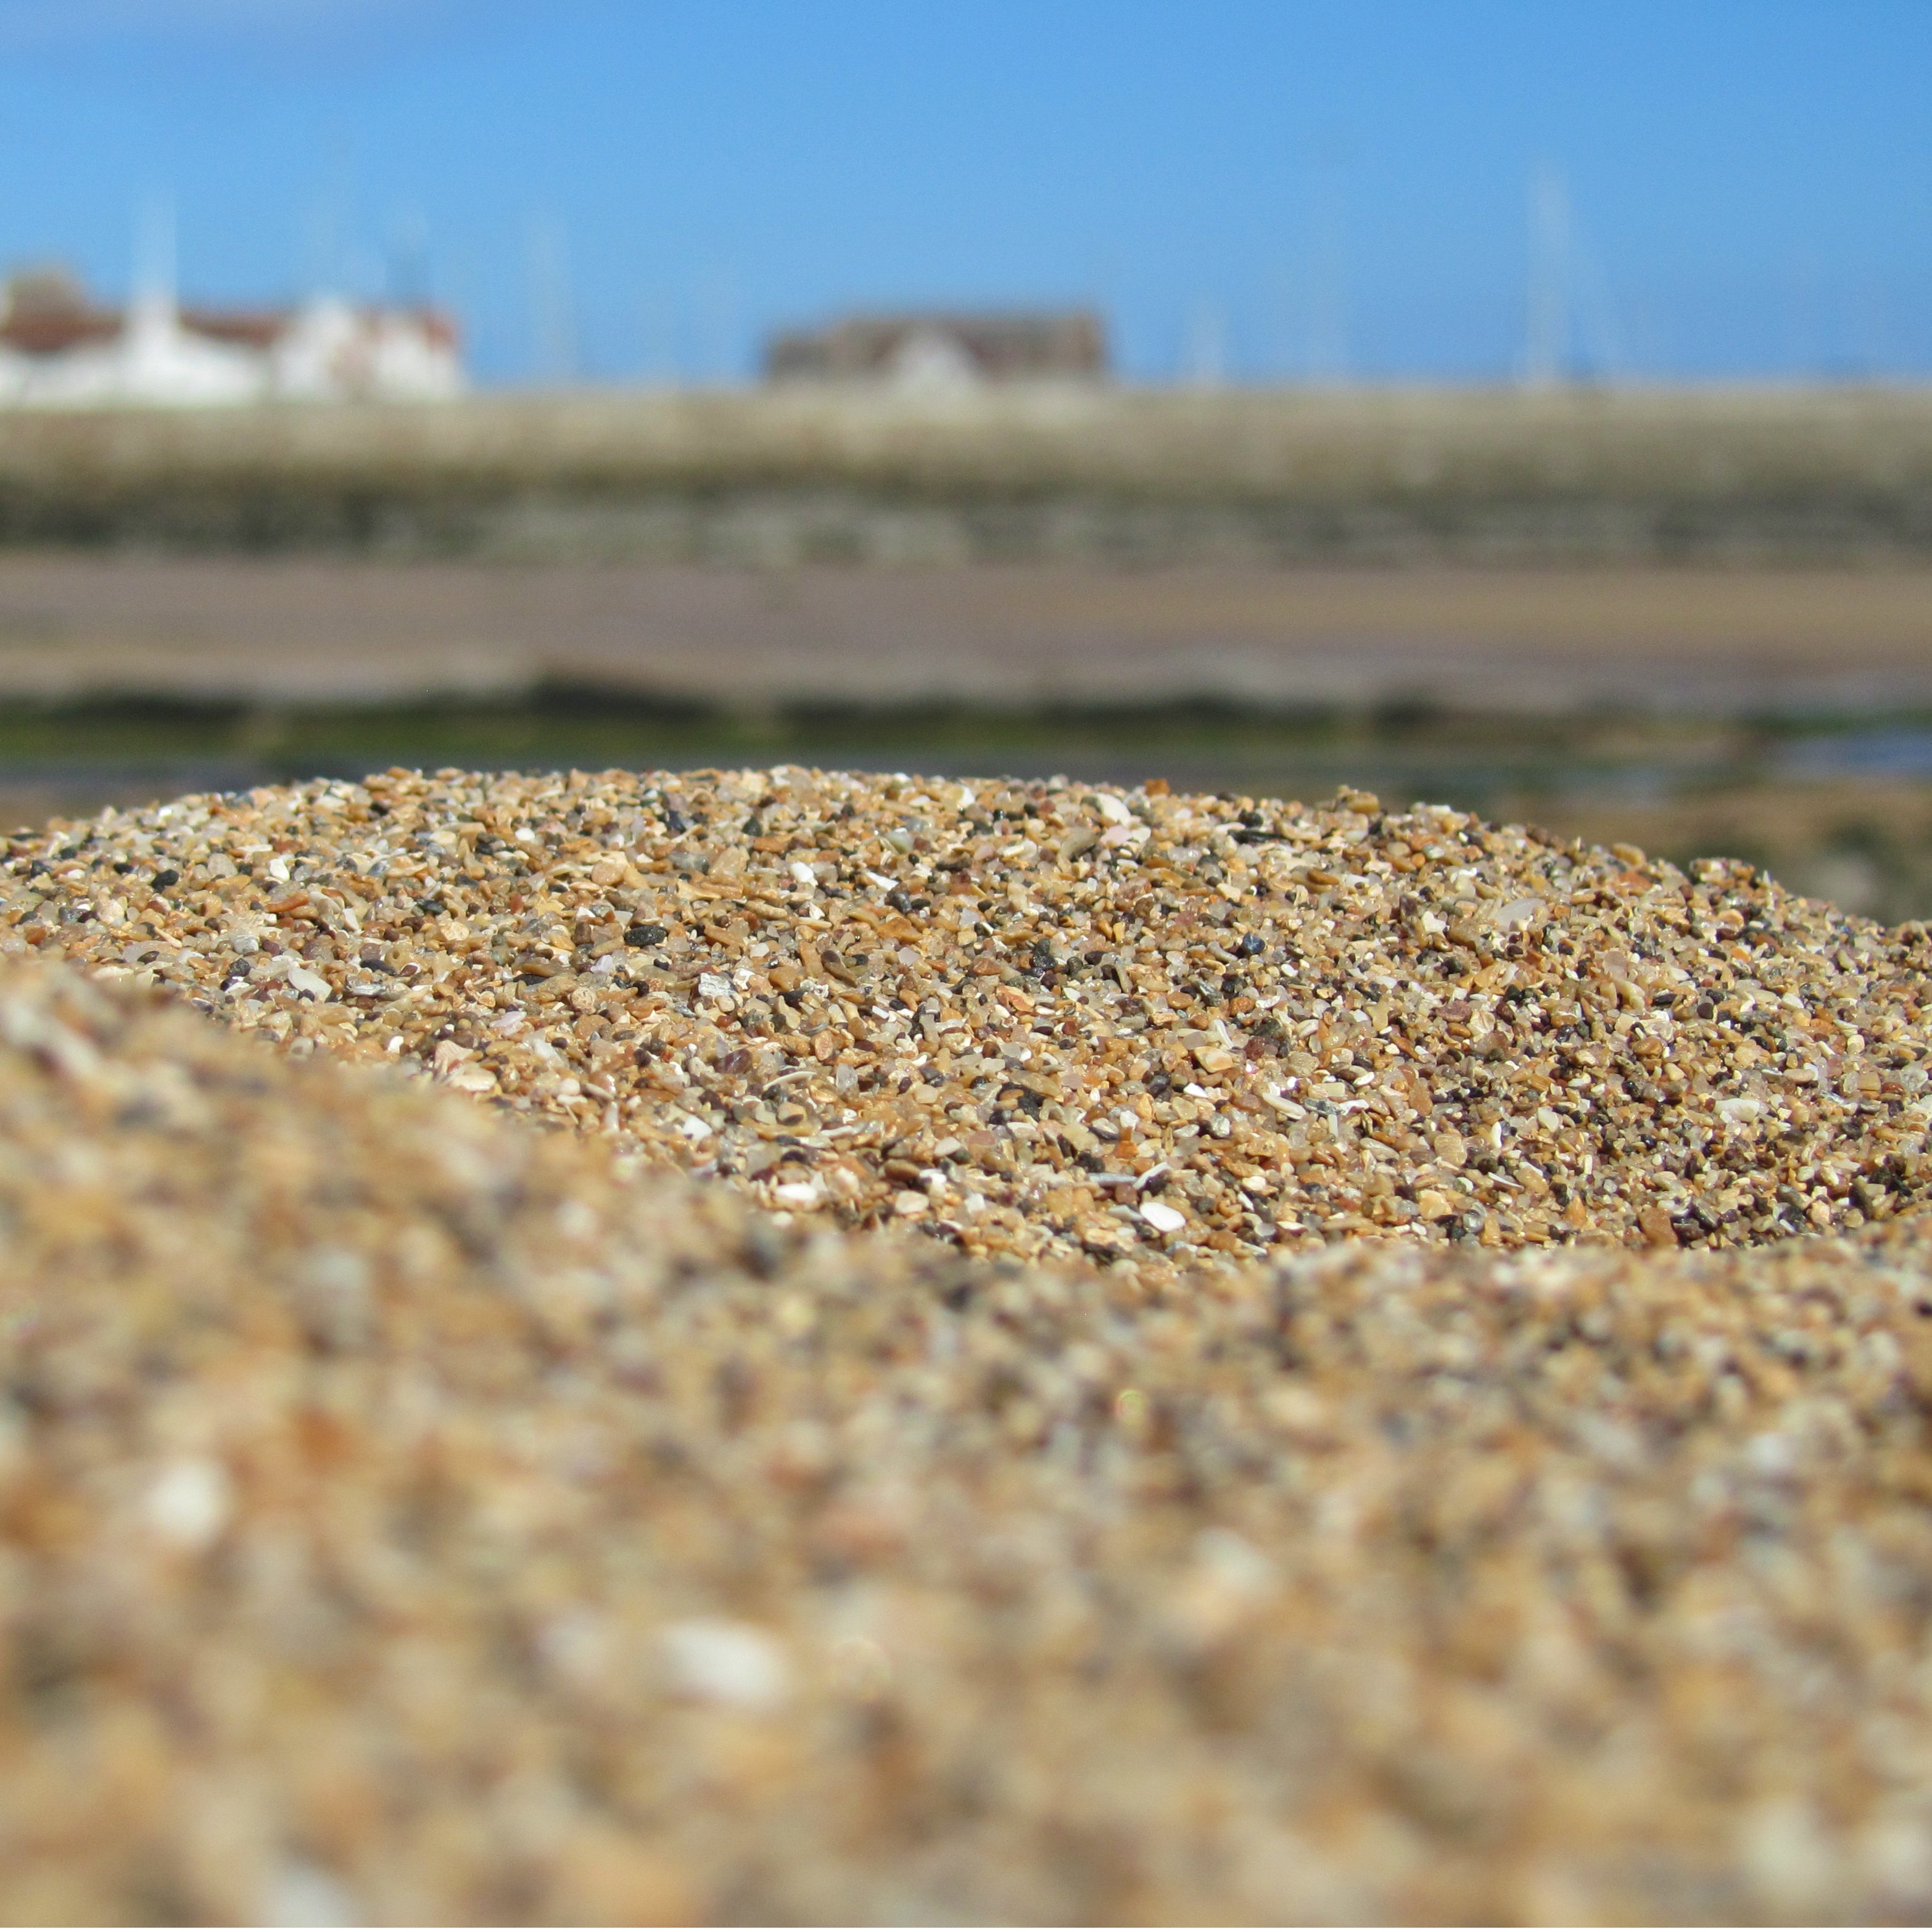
left=0, top=958, right=1932, bottom=1922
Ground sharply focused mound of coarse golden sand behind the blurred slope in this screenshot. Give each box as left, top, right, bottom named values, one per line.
left=0, top=769, right=1932, bottom=1271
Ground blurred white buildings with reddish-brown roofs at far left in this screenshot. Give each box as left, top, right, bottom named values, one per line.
left=0, top=268, right=464, bottom=410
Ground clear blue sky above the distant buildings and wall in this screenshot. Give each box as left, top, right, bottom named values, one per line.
left=0, top=0, right=1932, bottom=381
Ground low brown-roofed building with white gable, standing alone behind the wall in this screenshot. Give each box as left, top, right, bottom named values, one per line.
left=765, top=309, right=1107, bottom=389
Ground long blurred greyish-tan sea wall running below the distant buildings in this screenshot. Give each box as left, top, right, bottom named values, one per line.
left=0, top=386, right=1932, bottom=566
